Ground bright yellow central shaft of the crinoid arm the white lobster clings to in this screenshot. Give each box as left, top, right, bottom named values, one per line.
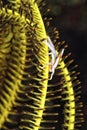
left=18, top=0, right=49, bottom=130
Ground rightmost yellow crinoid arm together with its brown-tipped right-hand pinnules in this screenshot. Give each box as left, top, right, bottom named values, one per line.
left=59, top=60, right=84, bottom=130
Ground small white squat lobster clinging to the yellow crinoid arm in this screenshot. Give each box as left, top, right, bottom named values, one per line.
left=44, top=36, right=64, bottom=80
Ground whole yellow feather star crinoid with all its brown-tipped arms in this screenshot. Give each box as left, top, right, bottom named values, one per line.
left=0, top=0, right=83, bottom=130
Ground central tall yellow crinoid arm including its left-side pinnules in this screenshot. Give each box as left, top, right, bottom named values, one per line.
left=13, top=0, right=49, bottom=130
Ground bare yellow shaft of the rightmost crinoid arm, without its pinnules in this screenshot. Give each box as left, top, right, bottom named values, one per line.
left=59, top=61, right=76, bottom=130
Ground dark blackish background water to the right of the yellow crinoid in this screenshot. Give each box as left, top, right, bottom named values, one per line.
left=46, top=0, right=87, bottom=130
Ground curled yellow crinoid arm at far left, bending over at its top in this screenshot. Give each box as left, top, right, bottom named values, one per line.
left=0, top=8, right=26, bottom=129
